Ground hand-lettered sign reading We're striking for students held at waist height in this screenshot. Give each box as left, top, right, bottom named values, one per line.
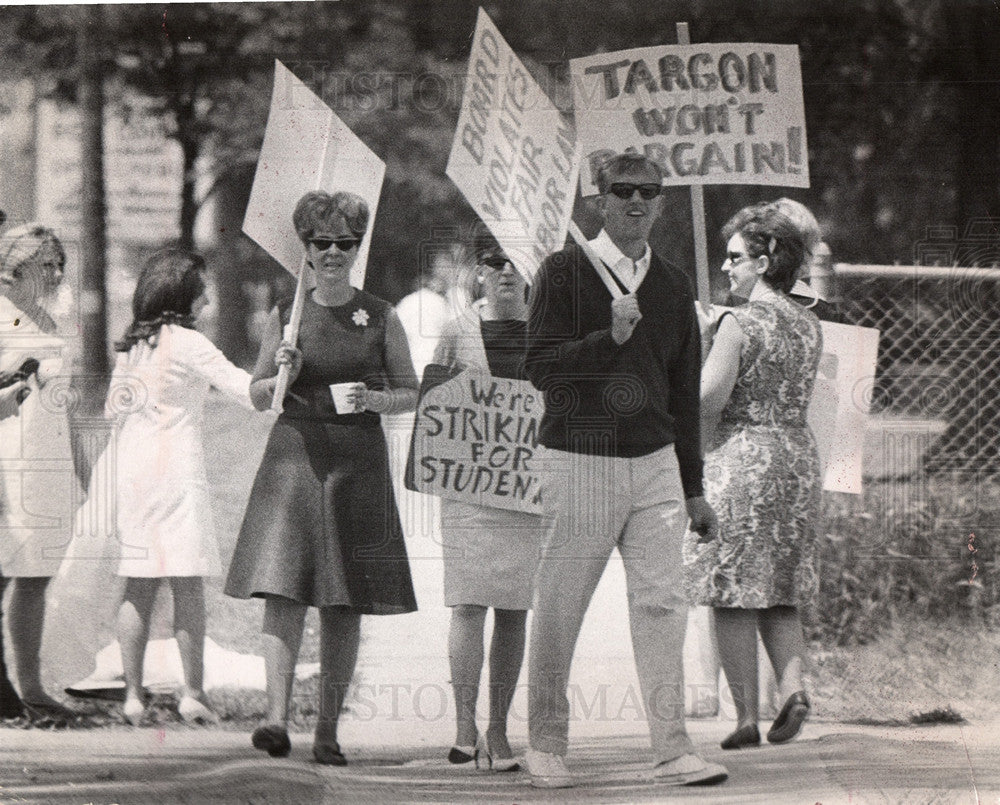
left=405, top=363, right=543, bottom=514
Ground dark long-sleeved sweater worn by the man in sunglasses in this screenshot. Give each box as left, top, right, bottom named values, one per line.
left=525, top=244, right=703, bottom=497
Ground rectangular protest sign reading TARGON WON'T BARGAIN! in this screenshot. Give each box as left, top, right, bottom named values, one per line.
left=569, top=43, right=809, bottom=195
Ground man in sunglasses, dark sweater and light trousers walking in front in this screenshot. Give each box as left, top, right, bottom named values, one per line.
left=525, top=154, right=727, bottom=788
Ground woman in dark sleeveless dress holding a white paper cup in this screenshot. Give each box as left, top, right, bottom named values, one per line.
left=226, top=191, right=418, bottom=765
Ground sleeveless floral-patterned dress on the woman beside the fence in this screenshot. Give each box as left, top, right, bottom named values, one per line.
left=684, top=296, right=823, bottom=609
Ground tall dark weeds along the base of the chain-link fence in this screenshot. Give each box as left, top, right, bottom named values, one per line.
left=804, top=475, right=1000, bottom=646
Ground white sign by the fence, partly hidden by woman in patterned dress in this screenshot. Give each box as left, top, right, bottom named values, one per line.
left=806, top=321, right=879, bottom=495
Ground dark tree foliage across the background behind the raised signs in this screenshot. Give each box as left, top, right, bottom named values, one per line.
left=0, top=0, right=1000, bottom=359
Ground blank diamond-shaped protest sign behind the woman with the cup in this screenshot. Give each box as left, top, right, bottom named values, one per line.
left=243, top=61, right=385, bottom=288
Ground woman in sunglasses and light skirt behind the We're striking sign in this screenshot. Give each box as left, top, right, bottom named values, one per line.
left=433, top=244, right=544, bottom=771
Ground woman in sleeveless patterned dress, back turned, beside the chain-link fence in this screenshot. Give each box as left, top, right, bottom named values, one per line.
left=685, top=205, right=822, bottom=749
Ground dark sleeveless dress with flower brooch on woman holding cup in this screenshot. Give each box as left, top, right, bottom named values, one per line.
left=225, top=291, right=417, bottom=615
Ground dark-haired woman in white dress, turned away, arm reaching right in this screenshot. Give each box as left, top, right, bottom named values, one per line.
left=106, top=249, right=252, bottom=724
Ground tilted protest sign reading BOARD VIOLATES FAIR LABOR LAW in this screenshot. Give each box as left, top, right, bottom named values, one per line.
left=446, top=9, right=579, bottom=280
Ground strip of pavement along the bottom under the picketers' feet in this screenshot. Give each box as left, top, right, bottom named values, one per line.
left=0, top=722, right=1000, bottom=805
